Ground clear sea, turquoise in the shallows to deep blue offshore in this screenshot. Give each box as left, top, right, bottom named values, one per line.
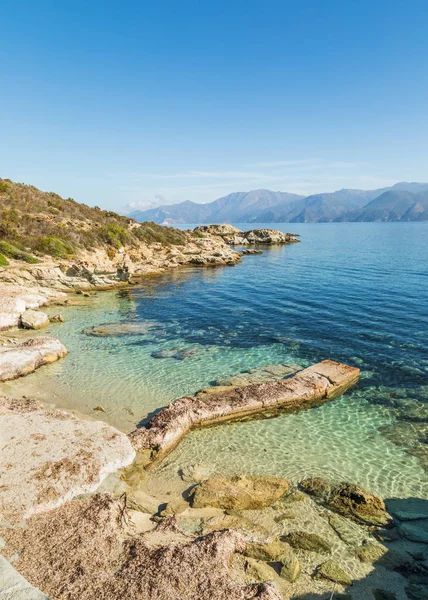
left=5, top=223, right=428, bottom=498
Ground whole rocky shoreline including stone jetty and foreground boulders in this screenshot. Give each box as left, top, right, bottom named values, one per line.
left=0, top=226, right=428, bottom=600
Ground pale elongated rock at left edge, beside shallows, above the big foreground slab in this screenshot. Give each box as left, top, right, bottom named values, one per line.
left=0, top=337, right=67, bottom=381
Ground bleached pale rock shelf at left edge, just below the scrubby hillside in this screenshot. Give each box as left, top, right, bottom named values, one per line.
left=0, top=284, right=66, bottom=330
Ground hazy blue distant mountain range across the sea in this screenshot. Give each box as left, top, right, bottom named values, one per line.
left=129, top=182, right=428, bottom=225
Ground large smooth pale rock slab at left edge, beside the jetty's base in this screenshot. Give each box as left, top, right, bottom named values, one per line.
left=0, top=398, right=135, bottom=520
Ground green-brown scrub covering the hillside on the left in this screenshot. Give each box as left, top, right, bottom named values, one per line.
left=0, top=179, right=189, bottom=266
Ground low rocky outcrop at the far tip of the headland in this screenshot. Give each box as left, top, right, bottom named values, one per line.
left=194, top=224, right=300, bottom=246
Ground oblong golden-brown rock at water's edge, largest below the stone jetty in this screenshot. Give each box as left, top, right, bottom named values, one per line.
left=192, top=475, right=290, bottom=510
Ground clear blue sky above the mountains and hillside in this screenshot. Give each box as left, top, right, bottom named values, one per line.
left=0, top=0, right=428, bottom=209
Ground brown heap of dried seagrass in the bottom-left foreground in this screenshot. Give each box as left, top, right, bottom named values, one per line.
left=5, top=494, right=281, bottom=600
